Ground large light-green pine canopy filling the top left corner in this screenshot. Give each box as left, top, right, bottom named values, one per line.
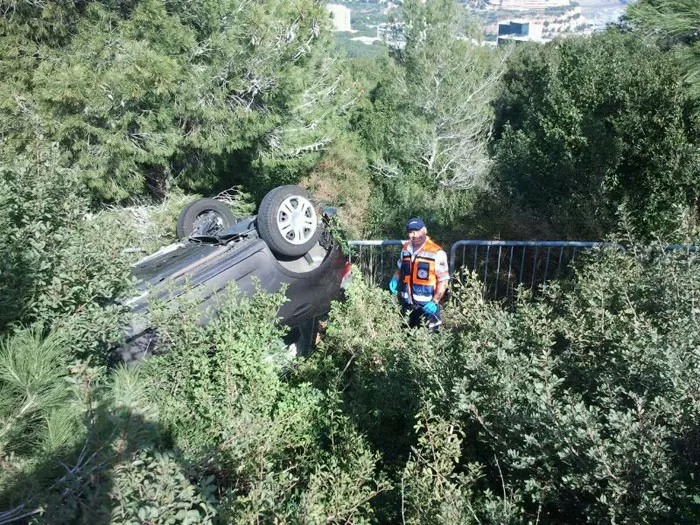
left=0, top=0, right=347, bottom=200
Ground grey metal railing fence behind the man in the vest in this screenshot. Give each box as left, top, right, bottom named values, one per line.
left=350, top=240, right=612, bottom=298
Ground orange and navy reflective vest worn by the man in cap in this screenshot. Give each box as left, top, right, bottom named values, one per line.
left=399, top=237, right=449, bottom=305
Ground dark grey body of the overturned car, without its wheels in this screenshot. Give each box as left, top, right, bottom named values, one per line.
left=118, top=213, right=349, bottom=362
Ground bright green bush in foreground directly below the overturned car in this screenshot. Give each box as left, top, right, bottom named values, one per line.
left=145, top=291, right=386, bottom=523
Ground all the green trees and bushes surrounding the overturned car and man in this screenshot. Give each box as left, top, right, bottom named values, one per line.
left=0, top=0, right=700, bottom=523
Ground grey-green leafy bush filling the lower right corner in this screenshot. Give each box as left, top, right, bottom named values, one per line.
left=430, top=248, right=700, bottom=522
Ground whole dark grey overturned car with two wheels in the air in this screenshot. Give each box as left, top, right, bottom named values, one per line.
left=117, top=185, right=350, bottom=363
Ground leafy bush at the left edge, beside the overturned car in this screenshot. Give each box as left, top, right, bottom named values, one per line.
left=0, top=143, right=130, bottom=327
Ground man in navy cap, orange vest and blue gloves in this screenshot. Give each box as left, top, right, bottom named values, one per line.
left=389, top=217, right=450, bottom=330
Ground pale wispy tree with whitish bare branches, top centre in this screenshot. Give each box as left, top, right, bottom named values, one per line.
left=356, top=0, right=502, bottom=189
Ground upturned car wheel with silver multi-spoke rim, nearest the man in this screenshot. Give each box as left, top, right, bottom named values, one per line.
left=257, top=185, right=321, bottom=257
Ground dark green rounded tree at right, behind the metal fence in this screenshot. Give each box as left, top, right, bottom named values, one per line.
left=494, top=31, right=700, bottom=238
